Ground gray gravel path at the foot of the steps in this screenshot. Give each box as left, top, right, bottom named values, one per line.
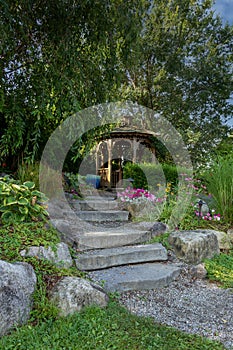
left=120, top=266, right=233, bottom=349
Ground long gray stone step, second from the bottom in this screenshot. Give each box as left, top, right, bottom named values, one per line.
left=75, top=243, right=167, bottom=271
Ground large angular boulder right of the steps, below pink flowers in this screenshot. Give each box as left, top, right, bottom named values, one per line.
left=168, top=230, right=220, bottom=264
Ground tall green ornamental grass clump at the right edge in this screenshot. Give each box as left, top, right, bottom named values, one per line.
left=204, top=155, right=233, bottom=223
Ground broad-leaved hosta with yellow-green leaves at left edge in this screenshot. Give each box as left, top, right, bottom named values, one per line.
left=0, top=176, right=48, bottom=224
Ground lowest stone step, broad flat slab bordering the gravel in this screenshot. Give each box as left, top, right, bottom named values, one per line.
left=89, top=263, right=182, bottom=292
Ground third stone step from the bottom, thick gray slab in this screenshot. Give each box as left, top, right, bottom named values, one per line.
left=78, top=227, right=151, bottom=250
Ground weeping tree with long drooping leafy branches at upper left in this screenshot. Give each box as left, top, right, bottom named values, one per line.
left=0, top=0, right=146, bottom=167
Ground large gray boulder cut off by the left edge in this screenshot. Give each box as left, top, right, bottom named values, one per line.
left=0, top=260, right=36, bottom=336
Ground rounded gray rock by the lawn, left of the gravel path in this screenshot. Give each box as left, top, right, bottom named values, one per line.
left=50, top=277, right=108, bottom=316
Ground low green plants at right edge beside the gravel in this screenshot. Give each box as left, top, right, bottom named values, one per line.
left=205, top=251, right=233, bottom=288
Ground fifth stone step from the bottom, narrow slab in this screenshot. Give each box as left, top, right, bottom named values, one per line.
left=72, top=199, right=118, bottom=211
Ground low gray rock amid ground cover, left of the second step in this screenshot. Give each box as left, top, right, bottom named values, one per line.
left=20, top=243, right=73, bottom=268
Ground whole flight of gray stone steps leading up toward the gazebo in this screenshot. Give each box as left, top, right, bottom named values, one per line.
left=55, top=191, right=182, bottom=292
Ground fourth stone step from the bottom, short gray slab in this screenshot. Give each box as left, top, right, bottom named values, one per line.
left=76, top=210, right=129, bottom=222
